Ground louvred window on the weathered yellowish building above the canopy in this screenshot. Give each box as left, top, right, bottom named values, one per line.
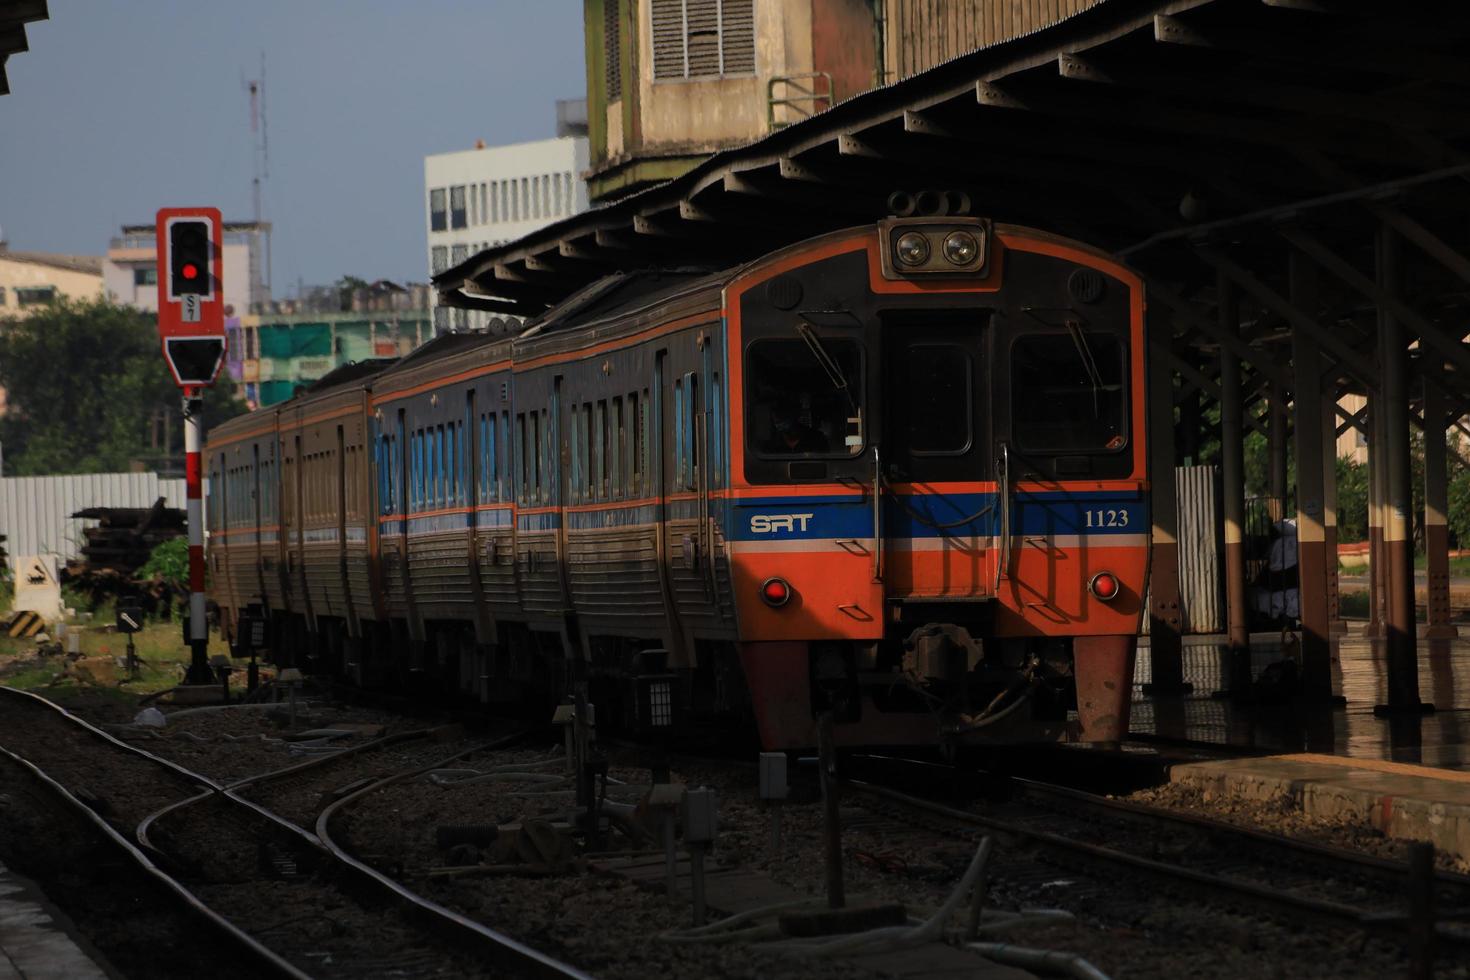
left=653, top=0, right=756, bottom=79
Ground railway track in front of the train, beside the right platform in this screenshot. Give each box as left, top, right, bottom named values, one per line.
left=847, top=760, right=1470, bottom=955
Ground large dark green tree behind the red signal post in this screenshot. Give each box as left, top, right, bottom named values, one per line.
left=0, top=300, right=245, bottom=476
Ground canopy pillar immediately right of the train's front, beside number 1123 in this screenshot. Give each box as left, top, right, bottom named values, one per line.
left=1144, top=337, right=1189, bottom=695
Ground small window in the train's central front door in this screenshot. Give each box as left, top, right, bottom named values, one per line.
left=888, top=342, right=975, bottom=455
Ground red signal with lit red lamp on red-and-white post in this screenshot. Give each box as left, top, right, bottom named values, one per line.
left=157, top=207, right=225, bottom=683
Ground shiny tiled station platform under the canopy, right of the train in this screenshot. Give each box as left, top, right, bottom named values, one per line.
left=1130, top=623, right=1470, bottom=861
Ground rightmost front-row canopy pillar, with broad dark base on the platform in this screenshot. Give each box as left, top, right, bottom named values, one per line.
left=1373, top=225, right=1433, bottom=713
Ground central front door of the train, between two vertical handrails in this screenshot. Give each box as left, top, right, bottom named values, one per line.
left=879, top=311, right=998, bottom=598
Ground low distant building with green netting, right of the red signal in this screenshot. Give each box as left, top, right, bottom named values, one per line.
left=235, top=279, right=432, bottom=408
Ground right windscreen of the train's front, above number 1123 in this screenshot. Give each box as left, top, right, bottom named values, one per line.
left=1011, top=329, right=1127, bottom=453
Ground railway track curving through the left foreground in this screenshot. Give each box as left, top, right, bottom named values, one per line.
left=0, top=688, right=585, bottom=980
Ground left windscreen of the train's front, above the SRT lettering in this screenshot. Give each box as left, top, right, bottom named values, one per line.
left=745, top=338, right=863, bottom=457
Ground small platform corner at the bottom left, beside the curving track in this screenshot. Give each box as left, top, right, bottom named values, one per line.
left=0, top=864, right=113, bottom=980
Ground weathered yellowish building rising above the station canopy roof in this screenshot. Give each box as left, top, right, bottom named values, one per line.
left=584, top=0, right=1098, bottom=201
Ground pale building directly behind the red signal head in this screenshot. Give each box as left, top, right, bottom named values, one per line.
left=103, top=222, right=270, bottom=316
